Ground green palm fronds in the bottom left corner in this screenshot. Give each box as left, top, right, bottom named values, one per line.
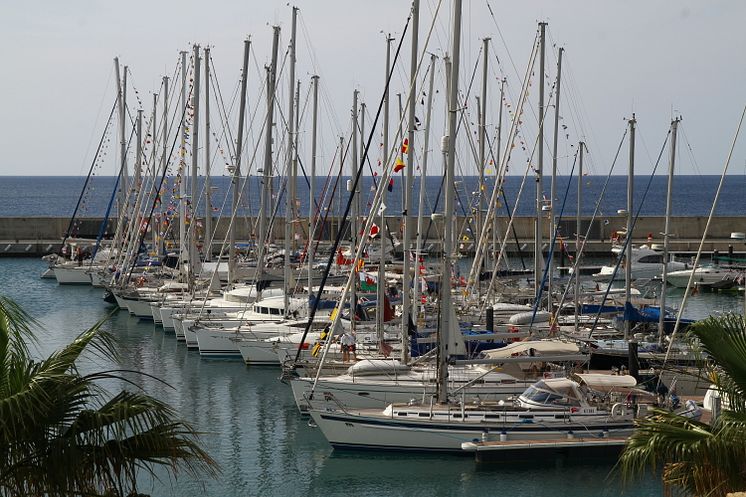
left=0, top=297, right=217, bottom=497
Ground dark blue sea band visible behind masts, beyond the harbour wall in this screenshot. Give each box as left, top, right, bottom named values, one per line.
left=0, top=175, right=746, bottom=217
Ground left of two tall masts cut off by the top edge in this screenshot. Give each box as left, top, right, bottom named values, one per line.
left=401, top=0, right=420, bottom=362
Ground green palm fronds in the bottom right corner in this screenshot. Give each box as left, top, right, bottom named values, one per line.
left=619, top=314, right=746, bottom=497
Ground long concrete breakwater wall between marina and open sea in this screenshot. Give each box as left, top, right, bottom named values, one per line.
left=0, top=215, right=746, bottom=257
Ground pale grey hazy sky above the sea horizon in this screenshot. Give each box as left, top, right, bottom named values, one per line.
left=0, top=0, right=746, bottom=175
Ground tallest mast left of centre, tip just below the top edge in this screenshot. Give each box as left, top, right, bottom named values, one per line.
left=283, top=7, right=298, bottom=318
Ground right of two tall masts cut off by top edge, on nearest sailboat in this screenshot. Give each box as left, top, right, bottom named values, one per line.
left=437, top=0, right=461, bottom=403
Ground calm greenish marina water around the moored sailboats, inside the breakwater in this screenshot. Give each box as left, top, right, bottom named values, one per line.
left=7, top=259, right=742, bottom=497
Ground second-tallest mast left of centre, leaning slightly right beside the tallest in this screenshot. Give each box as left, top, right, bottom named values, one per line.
left=256, top=26, right=280, bottom=297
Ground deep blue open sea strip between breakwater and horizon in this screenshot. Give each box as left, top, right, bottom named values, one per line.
left=0, top=175, right=746, bottom=217
